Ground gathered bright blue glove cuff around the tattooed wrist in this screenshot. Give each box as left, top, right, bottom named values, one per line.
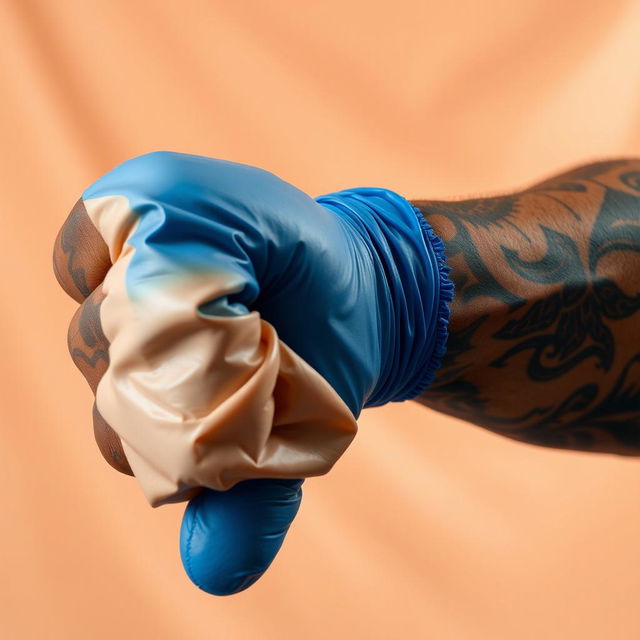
left=316, top=187, right=454, bottom=408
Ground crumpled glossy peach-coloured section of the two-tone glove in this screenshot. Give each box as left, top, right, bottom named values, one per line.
left=84, top=196, right=357, bottom=507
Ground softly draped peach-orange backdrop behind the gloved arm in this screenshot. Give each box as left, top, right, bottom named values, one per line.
left=0, top=0, right=640, bottom=640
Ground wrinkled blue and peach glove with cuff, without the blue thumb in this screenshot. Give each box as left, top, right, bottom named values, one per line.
left=82, top=152, right=453, bottom=507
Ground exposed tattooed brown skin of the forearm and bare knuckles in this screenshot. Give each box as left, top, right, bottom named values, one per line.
left=53, top=158, right=640, bottom=475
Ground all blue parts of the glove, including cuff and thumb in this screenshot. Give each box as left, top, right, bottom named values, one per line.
left=83, top=152, right=453, bottom=595
